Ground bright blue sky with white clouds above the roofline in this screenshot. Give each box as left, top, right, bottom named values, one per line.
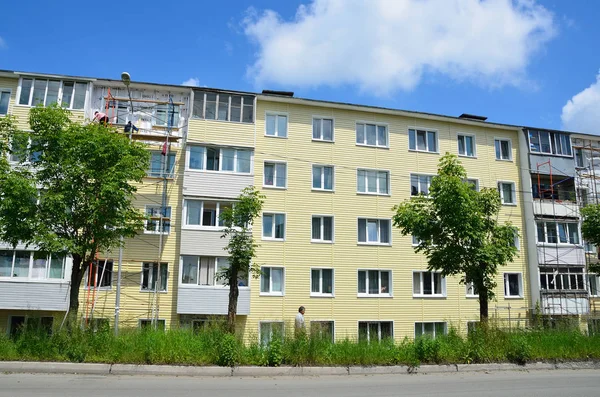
left=0, top=0, right=600, bottom=134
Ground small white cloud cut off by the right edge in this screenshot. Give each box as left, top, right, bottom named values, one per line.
left=560, top=70, right=600, bottom=135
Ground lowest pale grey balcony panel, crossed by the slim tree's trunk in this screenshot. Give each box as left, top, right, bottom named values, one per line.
left=177, top=286, right=250, bottom=315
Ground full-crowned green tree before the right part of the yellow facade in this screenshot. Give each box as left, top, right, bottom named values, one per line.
left=393, top=153, right=518, bottom=321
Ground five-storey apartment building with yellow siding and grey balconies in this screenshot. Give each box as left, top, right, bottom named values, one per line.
left=8, top=72, right=599, bottom=341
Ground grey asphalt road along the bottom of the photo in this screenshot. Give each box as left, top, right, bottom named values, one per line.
left=0, top=370, right=600, bottom=397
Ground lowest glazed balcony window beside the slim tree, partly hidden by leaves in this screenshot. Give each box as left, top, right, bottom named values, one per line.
left=181, top=255, right=238, bottom=287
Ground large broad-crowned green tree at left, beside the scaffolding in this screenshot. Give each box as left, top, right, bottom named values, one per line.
left=0, top=106, right=149, bottom=322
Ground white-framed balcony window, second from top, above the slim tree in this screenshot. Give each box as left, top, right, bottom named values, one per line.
left=187, top=146, right=253, bottom=174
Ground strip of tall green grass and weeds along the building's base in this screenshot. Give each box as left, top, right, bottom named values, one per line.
left=0, top=327, right=600, bottom=366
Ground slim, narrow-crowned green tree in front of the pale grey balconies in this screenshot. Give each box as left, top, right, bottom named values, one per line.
left=217, top=186, right=264, bottom=333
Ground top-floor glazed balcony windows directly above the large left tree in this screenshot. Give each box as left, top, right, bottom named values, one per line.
left=19, top=78, right=87, bottom=109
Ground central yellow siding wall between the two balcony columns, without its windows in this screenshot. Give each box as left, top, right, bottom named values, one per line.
left=246, top=98, right=528, bottom=340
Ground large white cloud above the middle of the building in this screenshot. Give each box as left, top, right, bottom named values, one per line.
left=243, top=0, right=556, bottom=95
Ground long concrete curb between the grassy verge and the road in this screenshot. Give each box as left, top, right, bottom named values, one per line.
left=0, top=361, right=600, bottom=377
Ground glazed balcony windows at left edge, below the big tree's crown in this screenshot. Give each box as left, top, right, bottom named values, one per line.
left=0, top=250, right=66, bottom=280
